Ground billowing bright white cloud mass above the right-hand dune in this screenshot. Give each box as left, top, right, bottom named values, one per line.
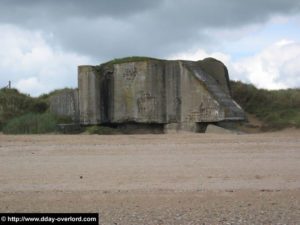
left=233, top=40, right=300, bottom=89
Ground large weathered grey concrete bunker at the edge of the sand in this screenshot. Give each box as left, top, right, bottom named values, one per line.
left=49, top=59, right=245, bottom=132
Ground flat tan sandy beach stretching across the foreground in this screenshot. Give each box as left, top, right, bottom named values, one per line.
left=0, top=131, right=300, bottom=224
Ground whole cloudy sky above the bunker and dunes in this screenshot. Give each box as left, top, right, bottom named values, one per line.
left=0, top=0, right=300, bottom=96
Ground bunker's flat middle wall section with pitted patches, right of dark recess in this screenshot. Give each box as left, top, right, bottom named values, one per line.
left=111, top=61, right=166, bottom=123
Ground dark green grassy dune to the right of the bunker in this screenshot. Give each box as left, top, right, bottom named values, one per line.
left=230, top=81, right=300, bottom=130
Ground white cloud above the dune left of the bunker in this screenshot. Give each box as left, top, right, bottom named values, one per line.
left=0, top=25, right=91, bottom=96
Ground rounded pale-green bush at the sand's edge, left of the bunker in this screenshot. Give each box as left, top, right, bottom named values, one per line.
left=3, top=113, right=57, bottom=134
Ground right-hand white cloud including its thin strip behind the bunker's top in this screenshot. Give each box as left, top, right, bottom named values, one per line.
left=170, top=40, right=300, bottom=89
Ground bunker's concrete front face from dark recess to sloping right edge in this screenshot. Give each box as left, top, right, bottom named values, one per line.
left=110, top=60, right=233, bottom=131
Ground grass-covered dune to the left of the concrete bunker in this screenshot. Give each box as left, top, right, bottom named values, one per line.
left=0, top=88, right=71, bottom=134
